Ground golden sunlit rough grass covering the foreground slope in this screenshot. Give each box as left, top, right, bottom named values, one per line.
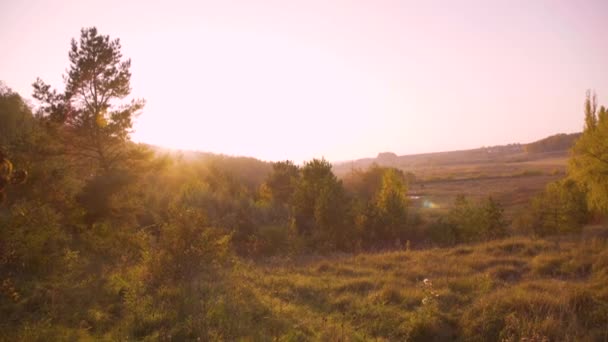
left=0, top=234, right=608, bottom=341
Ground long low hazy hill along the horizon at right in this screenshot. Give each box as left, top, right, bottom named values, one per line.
left=334, top=133, right=580, bottom=174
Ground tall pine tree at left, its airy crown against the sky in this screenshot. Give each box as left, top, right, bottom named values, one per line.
left=33, top=27, right=154, bottom=225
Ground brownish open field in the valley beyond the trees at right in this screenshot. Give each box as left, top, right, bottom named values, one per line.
left=334, top=145, right=569, bottom=218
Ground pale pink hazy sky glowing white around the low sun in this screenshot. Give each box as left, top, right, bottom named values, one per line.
left=0, top=0, right=608, bottom=162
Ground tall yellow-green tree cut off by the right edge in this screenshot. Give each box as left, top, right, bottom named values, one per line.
left=568, top=92, right=608, bottom=214
